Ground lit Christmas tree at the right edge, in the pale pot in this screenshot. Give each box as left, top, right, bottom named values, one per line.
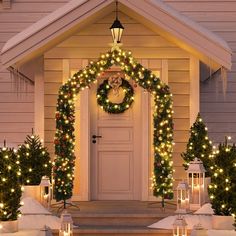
left=208, top=139, right=236, bottom=221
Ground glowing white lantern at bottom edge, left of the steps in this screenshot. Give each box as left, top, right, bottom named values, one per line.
left=59, top=210, right=73, bottom=236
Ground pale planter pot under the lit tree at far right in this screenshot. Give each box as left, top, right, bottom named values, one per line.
left=212, top=215, right=234, bottom=230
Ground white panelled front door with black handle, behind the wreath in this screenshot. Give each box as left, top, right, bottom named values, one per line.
left=90, top=74, right=142, bottom=200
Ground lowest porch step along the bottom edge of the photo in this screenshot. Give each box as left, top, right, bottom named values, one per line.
left=53, top=226, right=172, bottom=236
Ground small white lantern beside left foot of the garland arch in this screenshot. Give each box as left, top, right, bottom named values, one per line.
left=39, top=176, right=51, bottom=208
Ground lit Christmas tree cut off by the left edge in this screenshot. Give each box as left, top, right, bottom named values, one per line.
left=0, top=142, right=21, bottom=221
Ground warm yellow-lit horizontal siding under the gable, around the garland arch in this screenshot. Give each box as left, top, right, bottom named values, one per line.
left=44, top=13, right=190, bottom=184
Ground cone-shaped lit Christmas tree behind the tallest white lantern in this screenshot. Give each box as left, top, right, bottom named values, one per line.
left=181, top=113, right=213, bottom=176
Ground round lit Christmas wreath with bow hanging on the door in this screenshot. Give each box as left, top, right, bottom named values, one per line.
left=97, top=74, right=134, bottom=114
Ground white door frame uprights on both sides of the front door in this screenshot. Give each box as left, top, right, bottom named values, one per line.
left=72, top=59, right=168, bottom=201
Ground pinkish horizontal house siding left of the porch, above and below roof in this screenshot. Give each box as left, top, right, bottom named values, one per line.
left=0, top=0, right=69, bottom=147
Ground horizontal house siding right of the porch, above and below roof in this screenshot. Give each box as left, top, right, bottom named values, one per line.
left=163, top=0, right=236, bottom=143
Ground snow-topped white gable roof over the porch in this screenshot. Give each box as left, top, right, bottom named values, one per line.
left=1, top=0, right=231, bottom=69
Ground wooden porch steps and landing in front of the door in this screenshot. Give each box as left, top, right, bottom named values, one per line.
left=53, top=201, right=176, bottom=236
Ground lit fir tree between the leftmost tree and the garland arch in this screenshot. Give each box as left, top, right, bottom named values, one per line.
left=18, top=135, right=52, bottom=185
